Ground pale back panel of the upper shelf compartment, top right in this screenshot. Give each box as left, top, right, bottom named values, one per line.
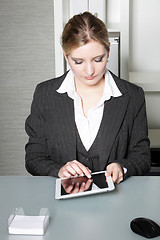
left=130, top=0, right=160, bottom=72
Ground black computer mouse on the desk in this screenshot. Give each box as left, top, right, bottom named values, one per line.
left=130, top=217, right=160, bottom=238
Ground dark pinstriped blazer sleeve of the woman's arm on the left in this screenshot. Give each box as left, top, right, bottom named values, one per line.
left=25, top=84, right=64, bottom=177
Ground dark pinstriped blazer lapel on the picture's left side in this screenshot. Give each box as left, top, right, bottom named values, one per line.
left=52, top=93, right=76, bottom=161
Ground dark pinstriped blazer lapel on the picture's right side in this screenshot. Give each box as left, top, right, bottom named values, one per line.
left=99, top=94, right=129, bottom=169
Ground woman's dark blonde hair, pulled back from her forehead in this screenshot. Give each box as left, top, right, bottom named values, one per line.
left=61, top=12, right=110, bottom=55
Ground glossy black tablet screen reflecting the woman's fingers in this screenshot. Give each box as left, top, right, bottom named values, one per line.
left=61, top=173, right=108, bottom=195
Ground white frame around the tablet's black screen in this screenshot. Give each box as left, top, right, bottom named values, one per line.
left=55, top=171, right=115, bottom=199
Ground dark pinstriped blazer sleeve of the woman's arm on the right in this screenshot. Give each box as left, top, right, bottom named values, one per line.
left=113, top=87, right=151, bottom=177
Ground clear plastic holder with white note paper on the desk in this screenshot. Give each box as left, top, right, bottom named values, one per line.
left=8, top=208, right=49, bottom=235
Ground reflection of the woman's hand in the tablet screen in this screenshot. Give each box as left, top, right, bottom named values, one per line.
left=62, top=176, right=93, bottom=194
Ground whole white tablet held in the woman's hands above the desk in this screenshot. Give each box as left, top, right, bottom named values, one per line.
left=55, top=171, right=115, bottom=199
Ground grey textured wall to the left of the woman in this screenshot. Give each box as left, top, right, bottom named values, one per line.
left=0, top=0, right=54, bottom=175
